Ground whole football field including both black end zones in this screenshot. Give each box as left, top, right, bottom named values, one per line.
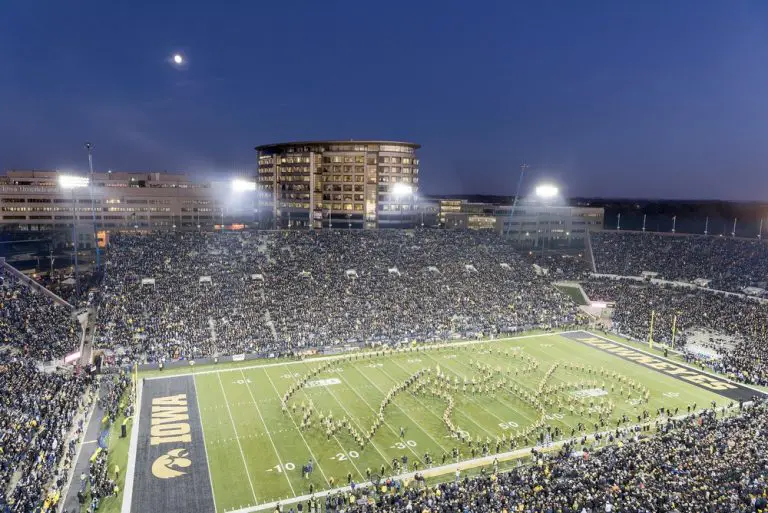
left=123, top=332, right=755, bottom=513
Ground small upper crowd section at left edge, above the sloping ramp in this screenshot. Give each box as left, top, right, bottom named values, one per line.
left=0, top=270, right=81, bottom=361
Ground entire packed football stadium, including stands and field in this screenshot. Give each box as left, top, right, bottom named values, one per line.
left=0, top=229, right=768, bottom=513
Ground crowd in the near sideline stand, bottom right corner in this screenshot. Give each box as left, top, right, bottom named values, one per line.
left=338, top=403, right=768, bottom=513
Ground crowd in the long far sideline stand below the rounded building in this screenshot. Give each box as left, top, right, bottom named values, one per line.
left=97, top=230, right=579, bottom=361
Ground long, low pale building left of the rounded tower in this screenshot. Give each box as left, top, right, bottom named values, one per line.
left=0, top=171, right=225, bottom=245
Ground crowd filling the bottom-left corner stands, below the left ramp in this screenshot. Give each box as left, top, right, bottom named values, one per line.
left=0, top=353, right=91, bottom=513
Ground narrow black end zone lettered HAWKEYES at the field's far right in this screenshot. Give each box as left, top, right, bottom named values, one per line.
left=560, top=331, right=765, bottom=401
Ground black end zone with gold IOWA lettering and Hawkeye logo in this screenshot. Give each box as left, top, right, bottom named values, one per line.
left=130, top=376, right=215, bottom=513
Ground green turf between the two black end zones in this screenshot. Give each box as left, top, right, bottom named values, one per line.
left=172, top=335, right=724, bottom=512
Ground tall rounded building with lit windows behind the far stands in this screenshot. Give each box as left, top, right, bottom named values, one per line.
left=256, top=141, right=420, bottom=228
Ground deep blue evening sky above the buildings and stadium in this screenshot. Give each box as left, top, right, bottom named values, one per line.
left=0, top=0, right=768, bottom=200
